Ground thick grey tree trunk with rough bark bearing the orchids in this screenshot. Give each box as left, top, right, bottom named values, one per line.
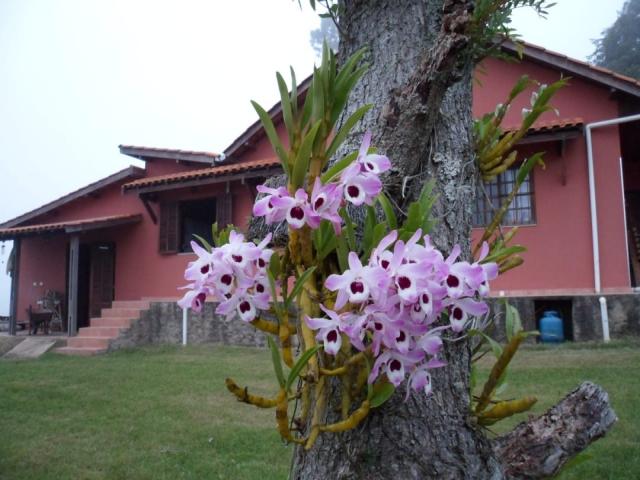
left=291, top=0, right=503, bottom=480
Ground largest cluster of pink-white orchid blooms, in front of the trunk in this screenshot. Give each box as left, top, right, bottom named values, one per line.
left=305, top=230, right=498, bottom=394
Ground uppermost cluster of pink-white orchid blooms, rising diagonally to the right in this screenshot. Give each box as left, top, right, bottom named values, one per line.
left=253, top=132, right=391, bottom=235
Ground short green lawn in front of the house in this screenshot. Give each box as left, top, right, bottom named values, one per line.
left=0, top=343, right=640, bottom=480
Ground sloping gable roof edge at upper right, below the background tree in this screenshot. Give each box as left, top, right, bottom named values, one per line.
left=502, top=41, right=640, bottom=98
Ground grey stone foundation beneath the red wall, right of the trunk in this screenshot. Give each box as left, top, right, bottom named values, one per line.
left=490, top=294, right=640, bottom=342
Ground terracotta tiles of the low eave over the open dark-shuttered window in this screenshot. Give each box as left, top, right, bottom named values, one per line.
left=122, top=158, right=280, bottom=192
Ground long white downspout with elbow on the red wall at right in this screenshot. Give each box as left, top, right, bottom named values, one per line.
left=585, top=114, right=640, bottom=342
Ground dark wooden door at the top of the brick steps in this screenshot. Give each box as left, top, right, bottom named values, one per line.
left=89, top=243, right=116, bottom=318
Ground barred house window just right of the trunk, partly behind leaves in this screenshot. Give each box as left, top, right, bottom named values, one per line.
left=473, top=168, right=535, bottom=227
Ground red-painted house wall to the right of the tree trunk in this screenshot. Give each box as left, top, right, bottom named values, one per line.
left=473, top=59, right=630, bottom=294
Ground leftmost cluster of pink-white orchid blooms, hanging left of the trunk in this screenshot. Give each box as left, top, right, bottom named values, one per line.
left=178, top=231, right=273, bottom=322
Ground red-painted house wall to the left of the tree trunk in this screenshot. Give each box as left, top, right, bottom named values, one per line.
left=17, top=173, right=252, bottom=321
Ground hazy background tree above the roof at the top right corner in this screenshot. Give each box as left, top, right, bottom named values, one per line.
left=589, top=0, right=640, bottom=78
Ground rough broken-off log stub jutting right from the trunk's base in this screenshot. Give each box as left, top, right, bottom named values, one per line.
left=494, top=382, right=617, bottom=479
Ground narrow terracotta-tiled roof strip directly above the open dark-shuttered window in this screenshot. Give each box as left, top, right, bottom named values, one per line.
left=122, top=157, right=281, bottom=193
